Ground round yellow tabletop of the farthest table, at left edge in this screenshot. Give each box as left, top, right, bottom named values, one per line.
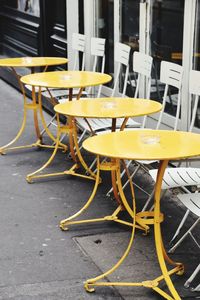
left=0, top=57, right=68, bottom=68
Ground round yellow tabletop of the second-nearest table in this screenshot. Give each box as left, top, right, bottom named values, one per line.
left=54, top=97, right=162, bottom=118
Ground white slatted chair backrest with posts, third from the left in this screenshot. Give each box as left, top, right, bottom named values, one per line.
left=111, top=43, right=131, bottom=97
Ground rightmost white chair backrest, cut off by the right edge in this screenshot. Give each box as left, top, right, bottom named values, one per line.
left=189, top=70, right=200, bottom=131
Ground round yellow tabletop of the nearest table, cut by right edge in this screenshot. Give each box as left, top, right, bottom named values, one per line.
left=83, top=130, right=200, bottom=160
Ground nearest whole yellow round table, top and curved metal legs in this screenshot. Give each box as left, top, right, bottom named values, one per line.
left=83, top=130, right=200, bottom=300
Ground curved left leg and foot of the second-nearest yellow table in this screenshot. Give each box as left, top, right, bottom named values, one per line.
left=60, top=157, right=102, bottom=230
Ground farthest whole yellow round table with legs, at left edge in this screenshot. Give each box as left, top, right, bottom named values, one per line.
left=0, top=57, right=68, bottom=154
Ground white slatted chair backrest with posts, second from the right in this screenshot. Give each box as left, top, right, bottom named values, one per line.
left=156, top=61, right=183, bottom=130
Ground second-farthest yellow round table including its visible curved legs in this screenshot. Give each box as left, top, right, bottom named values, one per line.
left=21, top=71, right=112, bottom=182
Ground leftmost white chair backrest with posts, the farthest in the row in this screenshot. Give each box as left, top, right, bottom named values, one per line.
left=72, top=33, right=86, bottom=71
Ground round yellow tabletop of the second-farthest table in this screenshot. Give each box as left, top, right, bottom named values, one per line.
left=21, top=71, right=112, bottom=89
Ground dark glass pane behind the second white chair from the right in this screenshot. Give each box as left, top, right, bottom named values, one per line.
left=151, top=0, right=184, bottom=120
